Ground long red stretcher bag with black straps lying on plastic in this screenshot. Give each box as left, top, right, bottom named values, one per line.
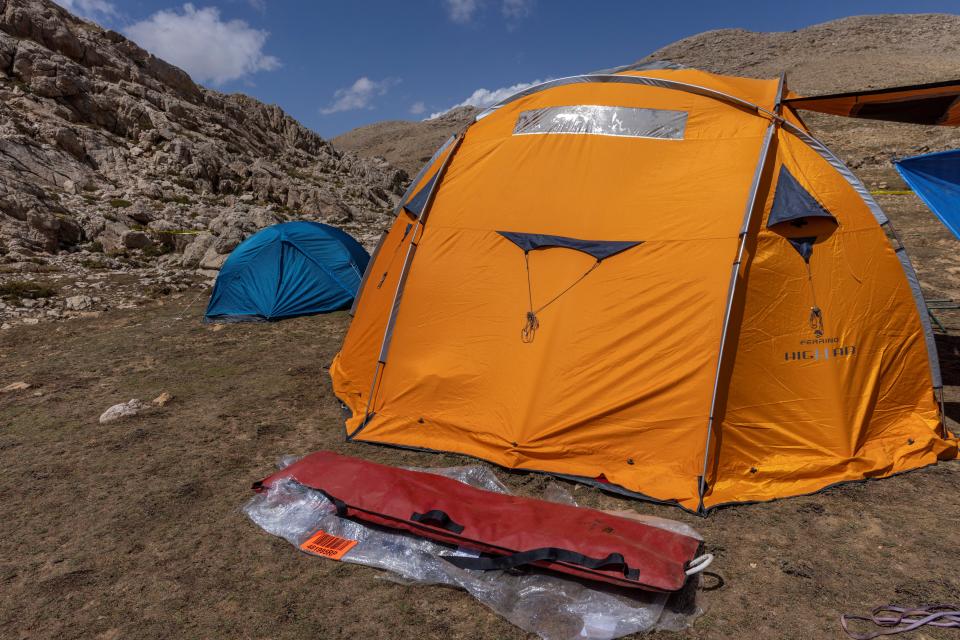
left=253, top=451, right=704, bottom=591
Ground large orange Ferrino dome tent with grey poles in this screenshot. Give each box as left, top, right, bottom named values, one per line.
left=331, top=69, right=957, bottom=512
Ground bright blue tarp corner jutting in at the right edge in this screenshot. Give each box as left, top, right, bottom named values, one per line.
left=894, top=149, right=960, bottom=239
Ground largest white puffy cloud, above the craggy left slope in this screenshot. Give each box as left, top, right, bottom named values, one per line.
left=124, top=3, right=280, bottom=84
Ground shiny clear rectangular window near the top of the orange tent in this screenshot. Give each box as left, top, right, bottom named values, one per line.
left=513, top=105, right=687, bottom=140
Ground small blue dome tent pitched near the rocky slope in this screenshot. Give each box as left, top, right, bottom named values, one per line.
left=204, top=221, right=370, bottom=321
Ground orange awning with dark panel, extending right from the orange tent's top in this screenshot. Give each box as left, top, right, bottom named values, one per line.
left=784, top=80, right=960, bottom=127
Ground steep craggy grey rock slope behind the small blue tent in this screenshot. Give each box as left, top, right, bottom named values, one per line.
left=0, top=0, right=407, bottom=328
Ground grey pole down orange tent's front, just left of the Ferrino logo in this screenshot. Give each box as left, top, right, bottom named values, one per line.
left=697, top=74, right=784, bottom=513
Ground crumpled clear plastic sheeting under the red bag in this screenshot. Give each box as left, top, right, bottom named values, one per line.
left=244, top=457, right=700, bottom=640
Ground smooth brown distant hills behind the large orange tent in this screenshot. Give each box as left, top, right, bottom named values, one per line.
left=334, top=14, right=960, bottom=184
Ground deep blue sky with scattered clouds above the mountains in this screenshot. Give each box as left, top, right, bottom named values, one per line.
left=60, top=0, right=960, bottom=137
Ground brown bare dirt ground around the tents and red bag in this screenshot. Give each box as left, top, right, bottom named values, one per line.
left=0, top=191, right=960, bottom=640
